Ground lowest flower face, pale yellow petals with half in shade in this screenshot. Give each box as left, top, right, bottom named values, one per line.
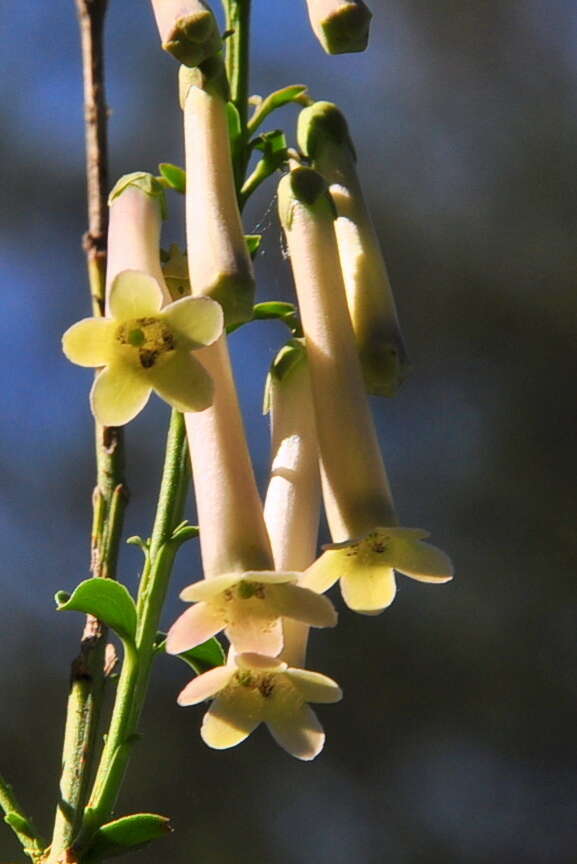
left=178, top=653, right=342, bottom=761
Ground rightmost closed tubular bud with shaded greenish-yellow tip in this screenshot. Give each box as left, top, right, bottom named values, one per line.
left=298, top=102, right=408, bottom=396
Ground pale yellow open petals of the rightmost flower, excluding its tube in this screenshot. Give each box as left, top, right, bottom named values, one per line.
left=303, top=527, right=453, bottom=615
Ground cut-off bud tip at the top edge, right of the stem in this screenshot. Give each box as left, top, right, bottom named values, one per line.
left=307, top=0, right=372, bottom=54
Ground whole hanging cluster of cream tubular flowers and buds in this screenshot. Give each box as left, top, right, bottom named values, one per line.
left=63, top=0, right=453, bottom=760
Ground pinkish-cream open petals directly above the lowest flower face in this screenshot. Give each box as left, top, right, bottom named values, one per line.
left=166, top=571, right=337, bottom=657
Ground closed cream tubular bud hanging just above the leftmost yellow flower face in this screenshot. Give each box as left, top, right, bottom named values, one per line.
left=181, top=58, right=255, bottom=327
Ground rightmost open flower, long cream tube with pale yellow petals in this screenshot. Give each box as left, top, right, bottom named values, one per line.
left=279, top=168, right=453, bottom=612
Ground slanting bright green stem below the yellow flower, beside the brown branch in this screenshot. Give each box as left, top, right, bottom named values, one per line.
left=77, top=411, right=188, bottom=847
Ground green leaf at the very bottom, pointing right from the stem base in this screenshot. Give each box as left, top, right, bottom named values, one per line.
left=82, top=813, right=172, bottom=864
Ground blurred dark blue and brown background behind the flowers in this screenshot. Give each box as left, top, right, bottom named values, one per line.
left=0, top=0, right=577, bottom=864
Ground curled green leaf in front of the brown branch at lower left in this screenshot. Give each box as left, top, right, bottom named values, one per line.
left=54, top=577, right=136, bottom=642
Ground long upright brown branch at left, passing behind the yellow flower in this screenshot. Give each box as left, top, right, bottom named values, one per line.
left=47, top=0, right=126, bottom=864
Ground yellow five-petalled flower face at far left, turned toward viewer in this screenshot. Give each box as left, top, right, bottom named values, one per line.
left=62, top=270, right=222, bottom=426
